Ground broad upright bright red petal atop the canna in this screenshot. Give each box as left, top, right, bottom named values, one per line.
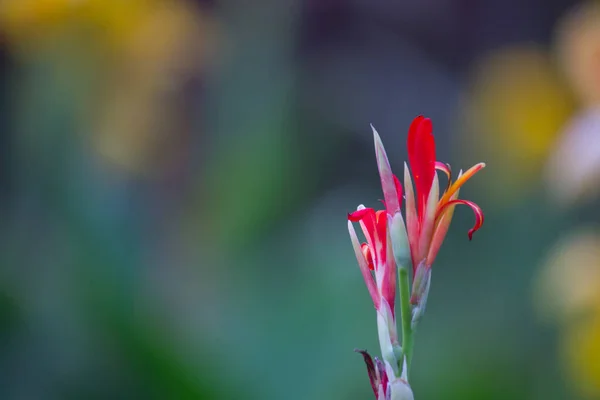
left=407, top=116, right=435, bottom=219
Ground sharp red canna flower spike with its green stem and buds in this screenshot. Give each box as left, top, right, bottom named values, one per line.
left=348, top=116, right=485, bottom=400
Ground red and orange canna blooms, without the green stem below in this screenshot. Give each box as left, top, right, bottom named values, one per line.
left=348, top=116, right=485, bottom=306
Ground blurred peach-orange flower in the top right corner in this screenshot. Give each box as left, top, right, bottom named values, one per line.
left=556, top=1, right=600, bottom=107
